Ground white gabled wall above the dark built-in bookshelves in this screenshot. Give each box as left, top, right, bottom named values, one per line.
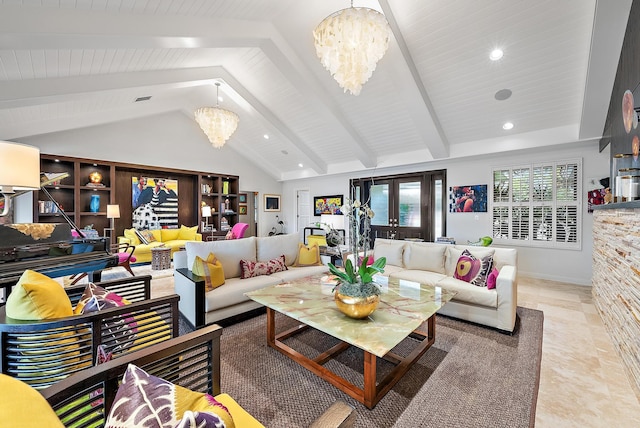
left=15, top=112, right=282, bottom=236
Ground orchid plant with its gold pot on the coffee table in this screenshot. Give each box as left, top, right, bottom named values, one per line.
left=329, top=195, right=387, bottom=319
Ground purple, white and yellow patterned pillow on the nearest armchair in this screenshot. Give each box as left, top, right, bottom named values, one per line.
left=105, top=364, right=235, bottom=428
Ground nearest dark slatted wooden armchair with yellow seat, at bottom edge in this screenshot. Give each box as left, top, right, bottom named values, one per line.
left=40, top=324, right=356, bottom=428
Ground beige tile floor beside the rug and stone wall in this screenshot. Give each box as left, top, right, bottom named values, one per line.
left=152, top=277, right=640, bottom=428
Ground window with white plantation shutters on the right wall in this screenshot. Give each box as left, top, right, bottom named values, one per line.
left=490, top=159, right=582, bottom=249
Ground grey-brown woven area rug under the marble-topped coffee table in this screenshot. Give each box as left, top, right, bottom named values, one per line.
left=221, top=307, right=543, bottom=428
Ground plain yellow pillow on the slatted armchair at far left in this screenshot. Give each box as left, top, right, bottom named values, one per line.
left=6, top=269, right=73, bottom=321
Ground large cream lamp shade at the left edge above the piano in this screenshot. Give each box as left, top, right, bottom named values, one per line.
left=0, top=141, right=40, bottom=193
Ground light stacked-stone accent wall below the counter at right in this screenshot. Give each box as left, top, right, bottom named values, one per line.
left=592, top=208, right=640, bottom=392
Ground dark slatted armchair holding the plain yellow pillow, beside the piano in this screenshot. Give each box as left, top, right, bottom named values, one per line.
left=0, top=276, right=179, bottom=389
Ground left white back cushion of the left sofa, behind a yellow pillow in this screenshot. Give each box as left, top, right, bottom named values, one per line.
left=184, top=236, right=256, bottom=280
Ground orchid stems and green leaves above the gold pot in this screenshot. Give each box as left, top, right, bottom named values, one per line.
left=329, top=199, right=387, bottom=297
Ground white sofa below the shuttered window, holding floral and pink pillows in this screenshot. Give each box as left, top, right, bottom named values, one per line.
left=373, top=238, right=518, bottom=332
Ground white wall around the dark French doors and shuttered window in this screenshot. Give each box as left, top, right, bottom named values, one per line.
left=282, top=142, right=609, bottom=285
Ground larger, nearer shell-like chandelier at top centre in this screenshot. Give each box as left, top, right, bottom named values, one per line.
left=313, top=0, right=391, bottom=95
